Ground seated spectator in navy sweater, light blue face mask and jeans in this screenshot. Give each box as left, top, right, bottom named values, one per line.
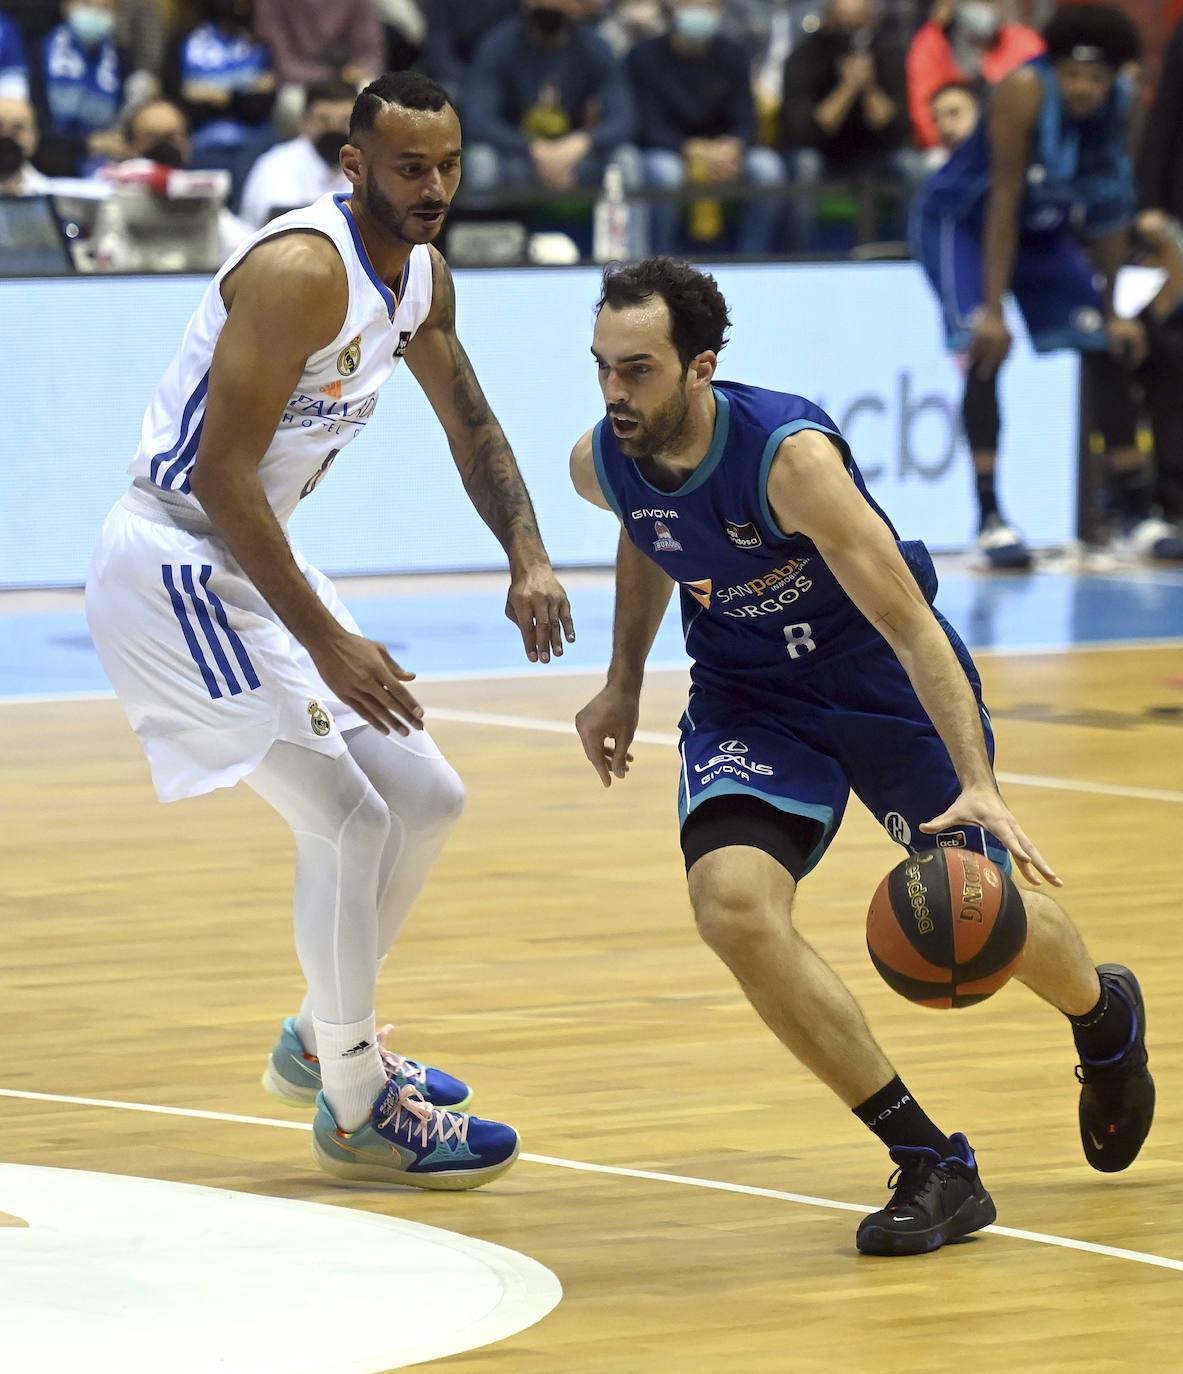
left=627, top=0, right=785, bottom=254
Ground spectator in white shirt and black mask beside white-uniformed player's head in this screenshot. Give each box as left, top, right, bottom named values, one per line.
left=239, top=81, right=354, bottom=229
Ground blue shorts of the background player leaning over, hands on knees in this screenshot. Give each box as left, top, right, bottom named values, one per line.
left=911, top=207, right=1107, bottom=353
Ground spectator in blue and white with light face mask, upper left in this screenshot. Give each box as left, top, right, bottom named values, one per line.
left=41, top=0, right=125, bottom=174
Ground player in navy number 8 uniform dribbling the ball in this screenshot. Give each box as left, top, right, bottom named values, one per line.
left=572, top=258, right=1154, bottom=1254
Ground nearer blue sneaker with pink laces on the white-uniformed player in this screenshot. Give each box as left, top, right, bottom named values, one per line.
left=312, top=1081, right=519, bottom=1190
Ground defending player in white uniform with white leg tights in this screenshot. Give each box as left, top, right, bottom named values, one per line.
left=87, top=71, right=574, bottom=1189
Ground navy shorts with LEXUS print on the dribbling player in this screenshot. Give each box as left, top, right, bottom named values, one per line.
left=677, top=636, right=1010, bottom=877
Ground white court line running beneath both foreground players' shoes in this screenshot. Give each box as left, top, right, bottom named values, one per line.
left=0, top=1088, right=1183, bottom=1274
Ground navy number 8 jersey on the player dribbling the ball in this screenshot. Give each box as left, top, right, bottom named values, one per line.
left=592, top=382, right=936, bottom=688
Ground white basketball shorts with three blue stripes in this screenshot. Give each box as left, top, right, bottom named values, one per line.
left=87, top=500, right=365, bottom=801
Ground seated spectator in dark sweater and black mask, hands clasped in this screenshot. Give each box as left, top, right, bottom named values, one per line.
left=464, top=0, right=640, bottom=200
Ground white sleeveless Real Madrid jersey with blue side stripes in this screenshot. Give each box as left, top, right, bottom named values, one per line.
left=129, top=195, right=431, bottom=528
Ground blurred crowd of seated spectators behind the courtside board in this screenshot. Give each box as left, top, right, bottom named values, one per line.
left=0, top=0, right=1183, bottom=269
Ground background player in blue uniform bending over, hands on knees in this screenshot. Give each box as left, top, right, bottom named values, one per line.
left=911, top=4, right=1183, bottom=567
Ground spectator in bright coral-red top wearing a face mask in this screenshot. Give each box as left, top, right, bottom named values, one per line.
left=908, top=0, right=1044, bottom=148
